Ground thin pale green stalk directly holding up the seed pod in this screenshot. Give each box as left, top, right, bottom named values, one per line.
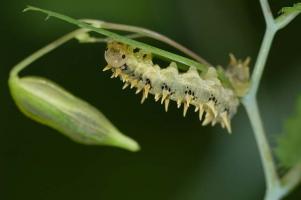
left=10, top=29, right=87, bottom=77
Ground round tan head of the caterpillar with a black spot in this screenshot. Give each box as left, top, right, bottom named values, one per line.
left=105, top=41, right=128, bottom=68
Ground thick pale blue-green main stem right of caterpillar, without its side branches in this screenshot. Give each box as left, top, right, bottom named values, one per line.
left=243, top=0, right=279, bottom=196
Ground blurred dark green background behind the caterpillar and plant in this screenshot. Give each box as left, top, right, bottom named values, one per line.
left=0, top=0, right=301, bottom=200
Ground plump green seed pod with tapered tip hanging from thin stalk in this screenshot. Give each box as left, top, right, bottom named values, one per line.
left=9, top=77, right=139, bottom=151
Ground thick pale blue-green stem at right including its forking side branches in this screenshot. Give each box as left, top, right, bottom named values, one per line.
left=242, top=0, right=301, bottom=200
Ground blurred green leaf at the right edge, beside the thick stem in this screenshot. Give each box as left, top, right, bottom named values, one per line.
left=276, top=96, right=301, bottom=167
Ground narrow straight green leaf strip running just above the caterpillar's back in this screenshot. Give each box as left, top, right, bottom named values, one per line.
left=24, top=6, right=208, bottom=72
